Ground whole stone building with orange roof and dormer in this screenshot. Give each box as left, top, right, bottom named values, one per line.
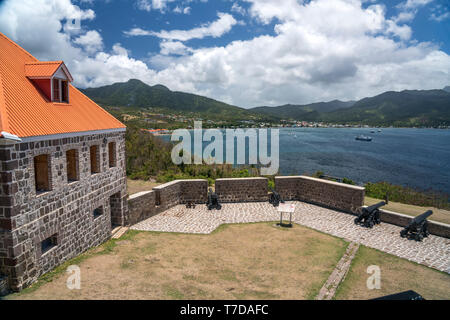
left=0, top=33, right=127, bottom=291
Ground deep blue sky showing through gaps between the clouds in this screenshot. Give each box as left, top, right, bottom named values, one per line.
left=80, top=0, right=450, bottom=59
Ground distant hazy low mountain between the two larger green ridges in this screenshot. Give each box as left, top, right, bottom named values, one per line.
left=250, top=100, right=355, bottom=121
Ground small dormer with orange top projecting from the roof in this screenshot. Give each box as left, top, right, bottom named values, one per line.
left=25, top=61, right=73, bottom=103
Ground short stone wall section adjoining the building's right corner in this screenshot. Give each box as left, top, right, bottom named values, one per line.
left=128, top=191, right=158, bottom=225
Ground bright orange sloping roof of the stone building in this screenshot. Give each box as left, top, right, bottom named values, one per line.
left=0, top=33, right=125, bottom=138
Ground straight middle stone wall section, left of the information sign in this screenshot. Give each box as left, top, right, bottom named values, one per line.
left=215, top=178, right=269, bottom=202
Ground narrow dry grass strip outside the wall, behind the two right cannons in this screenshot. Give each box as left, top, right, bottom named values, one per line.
left=364, top=197, right=450, bottom=224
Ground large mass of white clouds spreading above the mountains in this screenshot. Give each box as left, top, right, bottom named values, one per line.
left=0, top=0, right=450, bottom=107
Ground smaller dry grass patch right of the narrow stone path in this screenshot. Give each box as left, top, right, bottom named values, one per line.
left=335, top=246, right=450, bottom=300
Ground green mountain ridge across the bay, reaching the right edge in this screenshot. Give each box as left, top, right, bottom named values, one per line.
left=251, top=87, right=450, bottom=126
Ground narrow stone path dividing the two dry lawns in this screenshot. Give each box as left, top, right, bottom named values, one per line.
left=316, top=242, right=359, bottom=300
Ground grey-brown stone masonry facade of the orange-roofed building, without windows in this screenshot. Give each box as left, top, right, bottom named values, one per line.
left=0, top=132, right=128, bottom=291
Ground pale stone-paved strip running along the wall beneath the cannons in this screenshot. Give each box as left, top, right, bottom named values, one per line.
left=131, top=201, right=450, bottom=274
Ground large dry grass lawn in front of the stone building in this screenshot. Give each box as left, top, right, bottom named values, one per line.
left=6, top=223, right=348, bottom=300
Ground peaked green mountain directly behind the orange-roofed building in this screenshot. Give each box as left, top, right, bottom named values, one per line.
left=81, top=79, right=266, bottom=120
